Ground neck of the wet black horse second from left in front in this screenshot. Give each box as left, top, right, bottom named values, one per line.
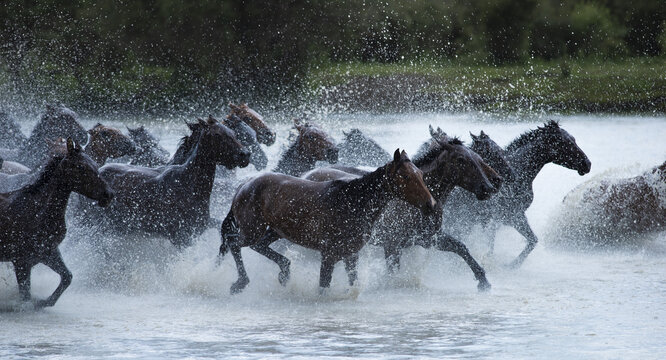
left=181, top=135, right=217, bottom=199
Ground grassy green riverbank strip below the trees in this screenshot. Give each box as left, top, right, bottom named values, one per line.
left=306, top=58, right=666, bottom=113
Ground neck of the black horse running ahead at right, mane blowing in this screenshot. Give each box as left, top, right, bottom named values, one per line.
left=506, top=137, right=554, bottom=184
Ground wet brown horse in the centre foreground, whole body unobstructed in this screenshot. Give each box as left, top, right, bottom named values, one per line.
left=220, top=150, right=437, bottom=294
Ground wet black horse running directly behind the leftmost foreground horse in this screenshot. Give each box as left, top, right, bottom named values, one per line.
left=80, top=118, right=250, bottom=246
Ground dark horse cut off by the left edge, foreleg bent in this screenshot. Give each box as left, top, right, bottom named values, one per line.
left=0, top=138, right=113, bottom=307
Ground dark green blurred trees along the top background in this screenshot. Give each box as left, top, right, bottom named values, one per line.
left=0, top=0, right=666, bottom=109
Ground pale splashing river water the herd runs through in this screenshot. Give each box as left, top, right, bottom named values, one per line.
left=0, top=113, right=666, bottom=359
